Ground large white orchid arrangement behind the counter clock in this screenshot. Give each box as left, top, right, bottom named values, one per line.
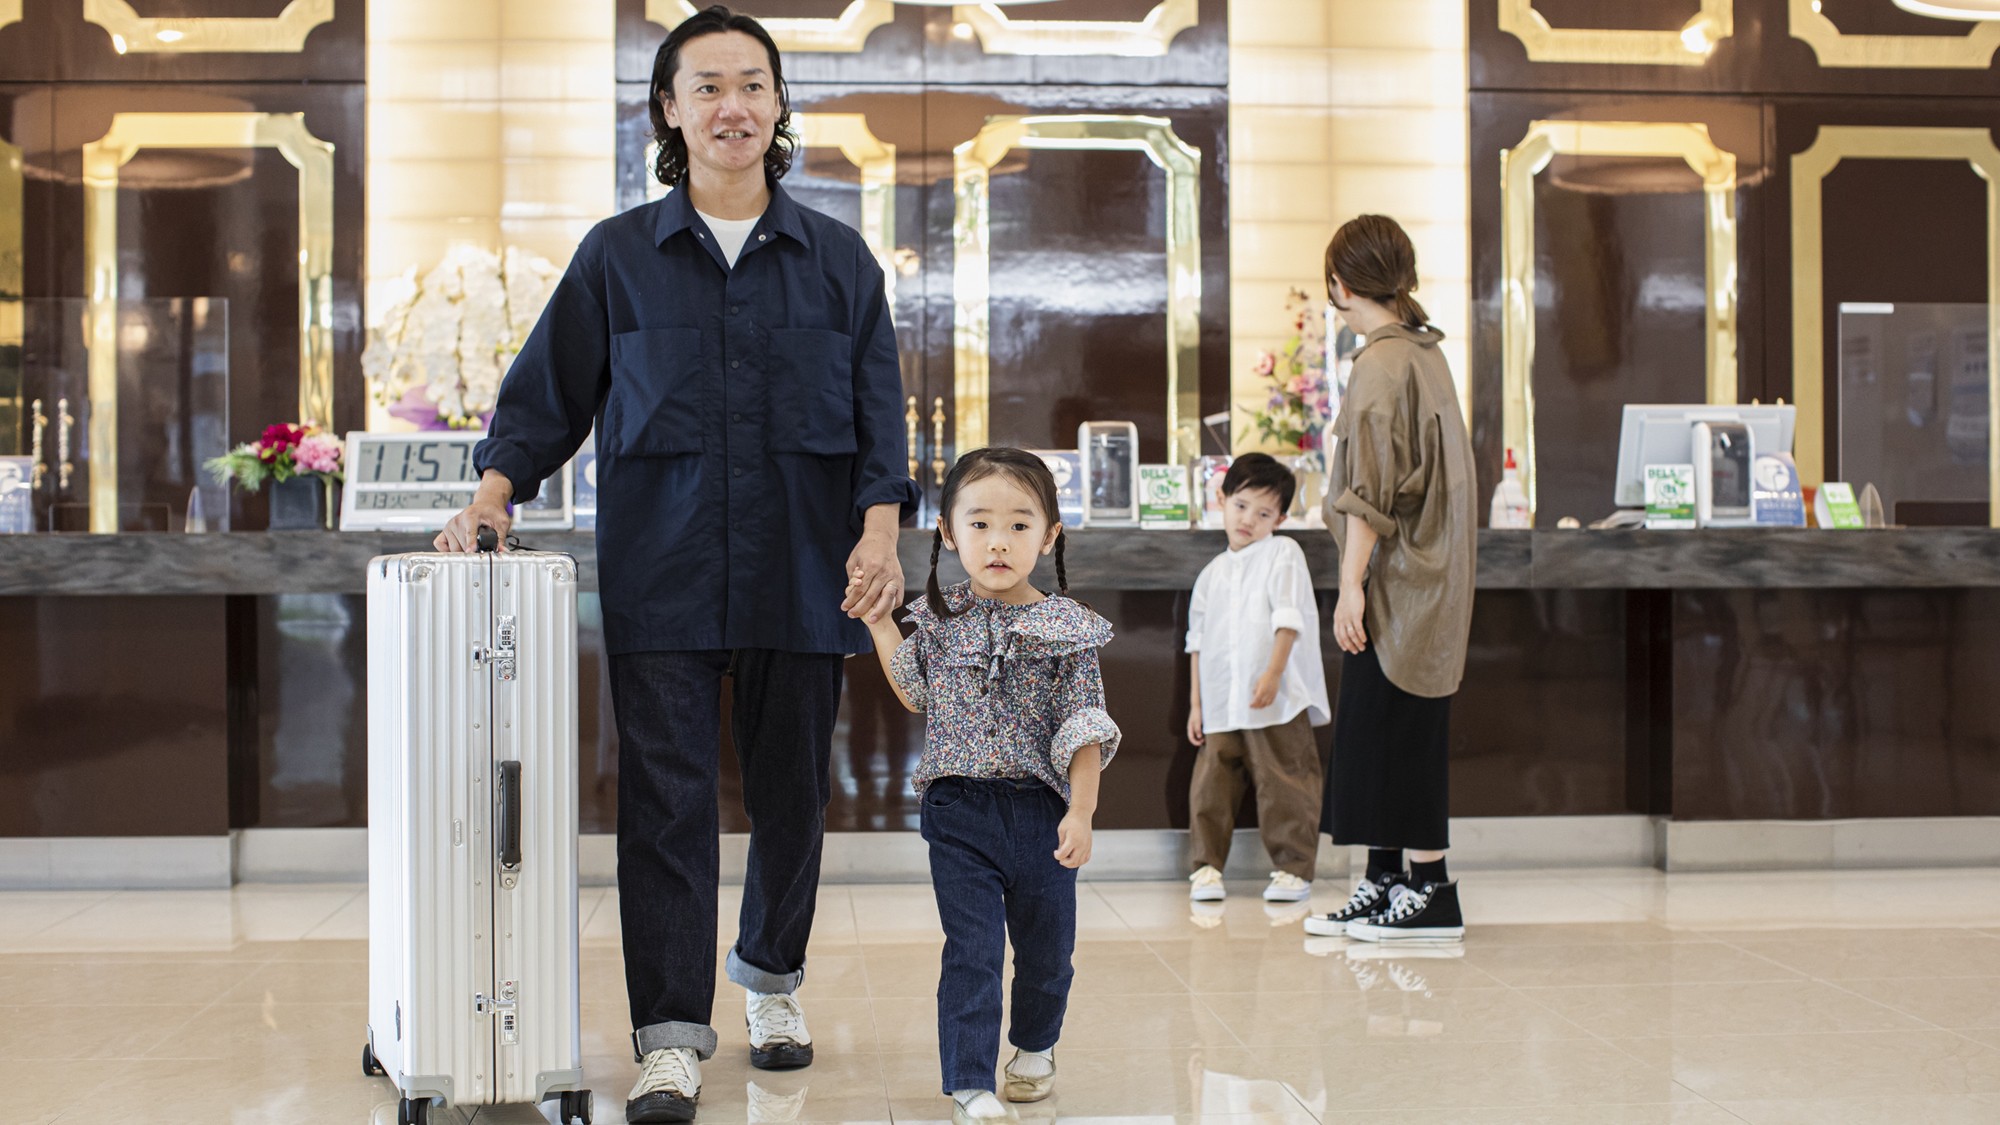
left=362, top=246, right=562, bottom=430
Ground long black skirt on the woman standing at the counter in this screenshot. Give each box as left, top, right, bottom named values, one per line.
left=1320, top=645, right=1452, bottom=851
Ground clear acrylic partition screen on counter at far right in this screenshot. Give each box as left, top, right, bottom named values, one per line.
left=1840, top=302, right=1992, bottom=526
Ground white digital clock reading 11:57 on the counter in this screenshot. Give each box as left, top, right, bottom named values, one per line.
left=340, top=430, right=574, bottom=530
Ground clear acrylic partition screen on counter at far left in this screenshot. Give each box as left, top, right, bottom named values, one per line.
left=0, top=298, right=230, bottom=532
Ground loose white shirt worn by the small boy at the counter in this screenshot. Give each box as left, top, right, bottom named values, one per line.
left=1188, top=534, right=1334, bottom=731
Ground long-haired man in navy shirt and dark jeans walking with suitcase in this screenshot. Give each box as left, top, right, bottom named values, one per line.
left=438, top=6, right=918, bottom=1121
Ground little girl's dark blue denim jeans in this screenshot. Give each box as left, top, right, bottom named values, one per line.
left=922, top=777, right=1076, bottom=1093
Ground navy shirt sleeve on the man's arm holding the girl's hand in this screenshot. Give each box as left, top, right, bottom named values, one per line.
left=854, top=254, right=918, bottom=530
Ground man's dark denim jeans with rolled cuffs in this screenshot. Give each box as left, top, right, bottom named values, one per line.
left=612, top=649, right=842, bottom=1059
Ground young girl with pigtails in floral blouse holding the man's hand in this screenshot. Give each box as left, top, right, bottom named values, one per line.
left=852, top=448, right=1118, bottom=1125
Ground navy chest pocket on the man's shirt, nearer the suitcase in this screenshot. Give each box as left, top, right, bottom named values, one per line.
left=598, top=328, right=704, bottom=456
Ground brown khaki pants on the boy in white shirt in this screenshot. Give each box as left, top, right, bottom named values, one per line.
left=1188, top=711, right=1324, bottom=881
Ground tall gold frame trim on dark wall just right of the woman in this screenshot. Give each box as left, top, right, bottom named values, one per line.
left=1500, top=120, right=1736, bottom=512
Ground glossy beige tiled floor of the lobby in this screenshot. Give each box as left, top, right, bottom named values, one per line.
left=19, top=871, right=2000, bottom=1125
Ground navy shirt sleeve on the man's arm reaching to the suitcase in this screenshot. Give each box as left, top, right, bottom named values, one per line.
left=472, top=230, right=612, bottom=504
